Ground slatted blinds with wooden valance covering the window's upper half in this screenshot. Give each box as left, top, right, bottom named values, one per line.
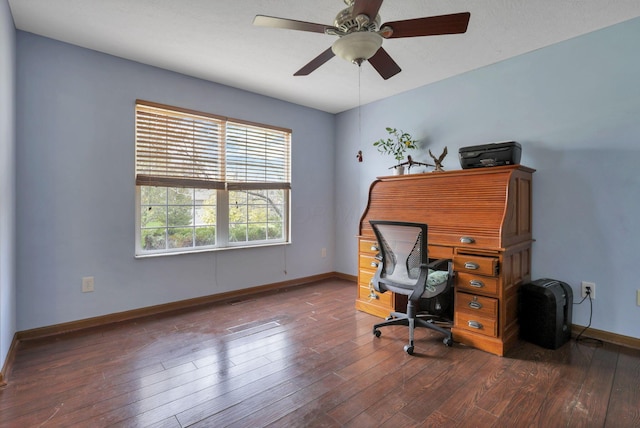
left=136, top=100, right=291, bottom=190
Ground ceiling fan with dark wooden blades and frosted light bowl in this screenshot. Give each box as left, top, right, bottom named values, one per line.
left=253, top=0, right=471, bottom=80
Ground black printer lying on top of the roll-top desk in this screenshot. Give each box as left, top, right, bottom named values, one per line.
left=458, top=141, right=522, bottom=169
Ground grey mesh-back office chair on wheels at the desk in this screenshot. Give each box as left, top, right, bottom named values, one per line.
left=370, top=220, right=454, bottom=355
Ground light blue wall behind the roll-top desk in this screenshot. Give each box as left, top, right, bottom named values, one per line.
left=336, top=19, right=640, bottom=338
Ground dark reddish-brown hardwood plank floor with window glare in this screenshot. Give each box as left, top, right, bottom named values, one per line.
left=0, top=279, right=640, bottom=428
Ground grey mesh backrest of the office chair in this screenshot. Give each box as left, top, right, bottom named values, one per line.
left=370, top=220, right=429, bottom=286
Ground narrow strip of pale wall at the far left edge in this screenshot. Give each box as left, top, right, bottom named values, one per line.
left=0, top=0, right=16, bottom=368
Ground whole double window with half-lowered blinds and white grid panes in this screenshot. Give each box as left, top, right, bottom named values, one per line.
left=136, top=100, right=291, bottom=255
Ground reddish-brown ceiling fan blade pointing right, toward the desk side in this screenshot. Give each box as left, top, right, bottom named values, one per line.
left=380, top=12, right=471, bottom=39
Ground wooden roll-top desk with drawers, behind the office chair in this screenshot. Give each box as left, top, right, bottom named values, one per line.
left=356, top=165, right=535, bottom=356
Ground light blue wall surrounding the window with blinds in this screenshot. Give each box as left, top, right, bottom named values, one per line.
left=17, top=31, right=335, bottom=330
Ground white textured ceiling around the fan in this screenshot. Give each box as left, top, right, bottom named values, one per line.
left=9, top=0, right=640, bottom=113
